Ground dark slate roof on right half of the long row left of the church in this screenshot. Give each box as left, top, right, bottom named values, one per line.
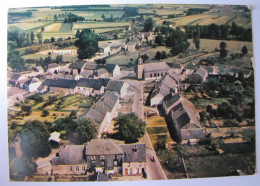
left=76, top=78, right=109, bottom=90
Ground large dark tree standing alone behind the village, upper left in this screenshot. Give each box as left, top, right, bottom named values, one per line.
left=75, top=29, right=99, bottom=59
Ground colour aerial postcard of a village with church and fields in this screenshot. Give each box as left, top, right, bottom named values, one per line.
left=7, top=4, right=256, bottom=182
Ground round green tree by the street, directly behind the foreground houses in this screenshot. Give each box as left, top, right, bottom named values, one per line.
left=114, top=113, right=146, bottom=143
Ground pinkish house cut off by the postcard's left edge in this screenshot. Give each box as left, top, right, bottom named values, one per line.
left=7, top=87, right=24, bottom=106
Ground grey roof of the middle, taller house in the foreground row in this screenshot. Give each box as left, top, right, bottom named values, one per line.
left=85, top=139, right=123, bottom=156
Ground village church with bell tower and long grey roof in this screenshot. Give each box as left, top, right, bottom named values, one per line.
left=136, top=57, right=171, bottom=80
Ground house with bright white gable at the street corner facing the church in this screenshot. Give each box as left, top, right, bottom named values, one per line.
left=106, top=80, right=129, bottom=98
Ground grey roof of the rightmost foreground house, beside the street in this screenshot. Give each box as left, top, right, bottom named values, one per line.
left=120, top=144, right=146, bottom=162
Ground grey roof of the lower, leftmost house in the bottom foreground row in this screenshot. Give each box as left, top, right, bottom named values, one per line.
left=52, top=145, right=86, bottom=165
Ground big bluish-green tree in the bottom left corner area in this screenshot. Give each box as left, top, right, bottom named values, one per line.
left=19, top=120, right=51, bottom=158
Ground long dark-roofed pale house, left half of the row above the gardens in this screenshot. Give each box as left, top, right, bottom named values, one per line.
left=48, top=79, right=76, bottom=94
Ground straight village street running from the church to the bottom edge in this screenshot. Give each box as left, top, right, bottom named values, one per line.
left=126, top=80, right=167, bottom=180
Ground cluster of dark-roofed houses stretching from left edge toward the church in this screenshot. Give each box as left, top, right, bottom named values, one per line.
left=8, top=61, right=120, bottom=106
